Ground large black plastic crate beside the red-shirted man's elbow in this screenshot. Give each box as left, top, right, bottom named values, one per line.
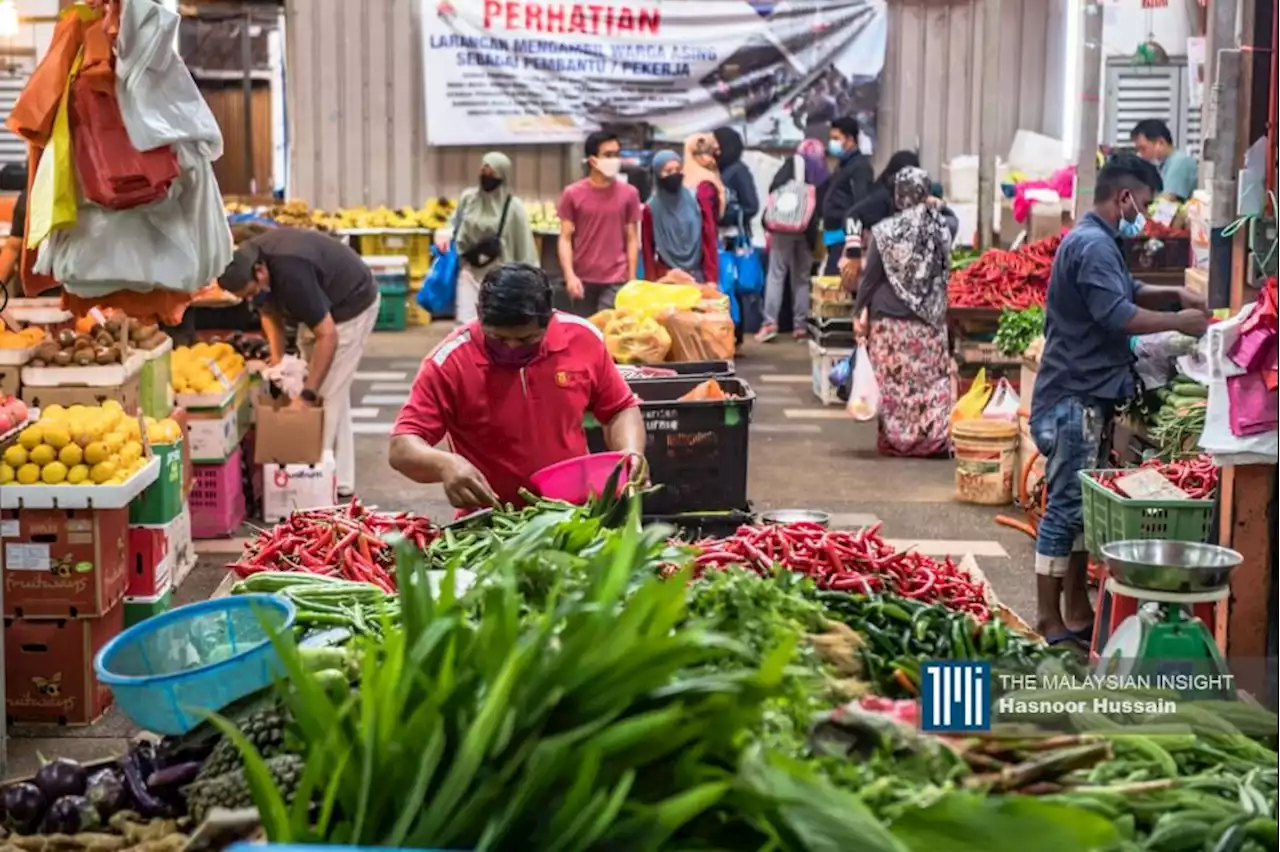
left=586, top=377, right=755, bottom=516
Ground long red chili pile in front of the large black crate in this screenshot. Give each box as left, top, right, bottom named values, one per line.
left=694, top=522, right=991, bottom=622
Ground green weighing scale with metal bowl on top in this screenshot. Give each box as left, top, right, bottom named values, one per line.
left=1094, top=540, right=1243, bottom=700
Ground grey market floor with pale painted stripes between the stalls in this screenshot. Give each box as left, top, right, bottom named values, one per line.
left=4, top=325, right=1034, bottom=778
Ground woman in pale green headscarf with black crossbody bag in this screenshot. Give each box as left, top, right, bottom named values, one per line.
left=435, top=151, right=539, bottom=325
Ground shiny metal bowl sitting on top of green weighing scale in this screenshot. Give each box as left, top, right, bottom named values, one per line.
left=1102, top=539, right=1244, bottom=594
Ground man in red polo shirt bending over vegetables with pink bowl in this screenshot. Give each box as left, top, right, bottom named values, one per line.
left=390, top=264, right=645, bottom=509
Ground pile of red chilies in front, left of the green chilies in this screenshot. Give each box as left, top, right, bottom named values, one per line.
left=227, top=499, right=439, bottom=592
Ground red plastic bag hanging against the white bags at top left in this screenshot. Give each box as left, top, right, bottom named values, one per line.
left=70, top=77, right=178, bottom=210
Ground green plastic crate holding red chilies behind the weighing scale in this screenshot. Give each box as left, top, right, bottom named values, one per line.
left=1079, top=469, right=1216, bottom=562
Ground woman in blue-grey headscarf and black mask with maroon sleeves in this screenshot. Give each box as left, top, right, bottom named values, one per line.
left=640, top=151, right=719, bottom=284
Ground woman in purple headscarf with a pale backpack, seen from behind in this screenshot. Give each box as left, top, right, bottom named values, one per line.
left=755, top=139, right=831, bottom=343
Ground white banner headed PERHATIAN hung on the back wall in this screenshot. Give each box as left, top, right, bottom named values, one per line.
left=422, top=0, right=886, bottom=150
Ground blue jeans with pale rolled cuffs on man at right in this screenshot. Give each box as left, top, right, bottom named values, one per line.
left=1030, top=397, right=1115, bottom=556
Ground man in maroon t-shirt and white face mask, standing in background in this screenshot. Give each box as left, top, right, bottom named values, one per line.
left=558, top=130, right=640, bottom=316
